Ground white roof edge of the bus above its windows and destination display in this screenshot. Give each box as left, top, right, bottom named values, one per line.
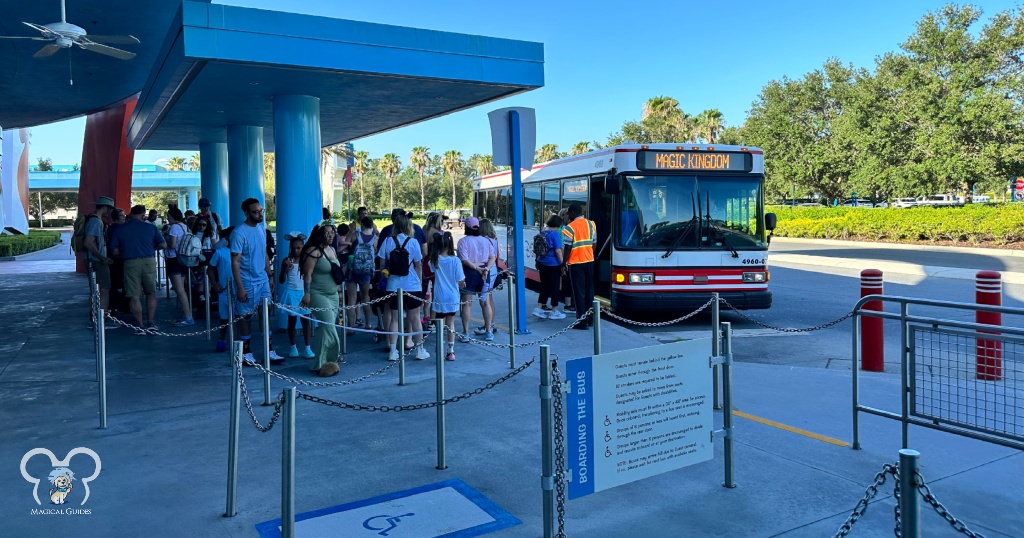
left=473, top=143, right=764, bottom=190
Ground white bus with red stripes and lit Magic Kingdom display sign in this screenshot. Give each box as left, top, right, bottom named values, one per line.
left=473, top=143, right=775, bottom=313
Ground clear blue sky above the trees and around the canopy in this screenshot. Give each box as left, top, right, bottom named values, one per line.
left=24, top=0, right=1016, bottom=164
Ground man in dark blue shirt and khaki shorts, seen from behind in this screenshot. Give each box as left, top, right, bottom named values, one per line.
left=111, top=205, right=167, bottom=336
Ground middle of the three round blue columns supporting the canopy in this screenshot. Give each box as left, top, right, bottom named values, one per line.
left=228, top=125, right=266, bottom=226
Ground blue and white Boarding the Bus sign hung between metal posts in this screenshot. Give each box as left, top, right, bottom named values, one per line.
left=563, top=338, right=714, bottom=499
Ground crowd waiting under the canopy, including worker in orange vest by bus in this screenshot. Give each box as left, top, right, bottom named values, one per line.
left=76, top=197, right=596, bottom=377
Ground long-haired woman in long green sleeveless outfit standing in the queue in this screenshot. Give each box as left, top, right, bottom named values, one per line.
left=299, top=221, right=341, bottom=377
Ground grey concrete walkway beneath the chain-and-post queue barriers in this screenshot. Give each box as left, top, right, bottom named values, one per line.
left=0, top=254, right=1024, bottom=538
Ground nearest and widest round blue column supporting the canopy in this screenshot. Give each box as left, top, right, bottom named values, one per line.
left=273, top=95, right=324, bottom=261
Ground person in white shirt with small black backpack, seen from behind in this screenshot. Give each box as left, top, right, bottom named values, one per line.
left=377, top=213, right=430, bottom=361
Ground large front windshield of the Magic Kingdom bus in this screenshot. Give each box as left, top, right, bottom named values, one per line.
left=615, top=175, right=767, bottom=252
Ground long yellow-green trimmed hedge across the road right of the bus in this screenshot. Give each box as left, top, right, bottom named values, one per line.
left=769, top=204, right=1024, bottom=246
